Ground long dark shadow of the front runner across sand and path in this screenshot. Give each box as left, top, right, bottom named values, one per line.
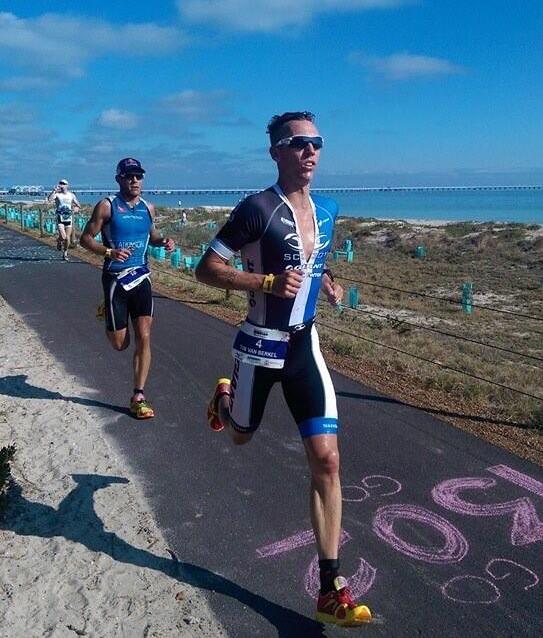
left=0, top=474, right=325, bottom=638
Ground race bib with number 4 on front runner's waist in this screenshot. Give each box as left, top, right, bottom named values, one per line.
left=232, top=321, right=290, bottom=369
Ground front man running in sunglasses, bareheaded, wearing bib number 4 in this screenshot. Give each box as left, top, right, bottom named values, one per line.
left=196, top=111, right=371, bottom=626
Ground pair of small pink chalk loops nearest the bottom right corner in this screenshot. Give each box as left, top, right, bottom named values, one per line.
left=441, top=558, right=539, bottom=605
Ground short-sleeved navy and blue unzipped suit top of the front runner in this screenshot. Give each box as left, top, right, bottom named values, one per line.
left=210, top=184, right=338, bottom=330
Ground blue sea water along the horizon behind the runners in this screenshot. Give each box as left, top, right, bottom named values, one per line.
left=5, top=189, right=543, bottom=224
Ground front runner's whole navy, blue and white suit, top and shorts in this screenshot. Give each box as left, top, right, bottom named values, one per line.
left=210, top=184, right=338, bottom=437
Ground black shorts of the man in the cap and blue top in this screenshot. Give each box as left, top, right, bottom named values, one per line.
left=102, top=272, right=153, bottom=332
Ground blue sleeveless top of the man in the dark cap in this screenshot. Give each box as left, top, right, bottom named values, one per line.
left=102, top=195, right=153, bottom=273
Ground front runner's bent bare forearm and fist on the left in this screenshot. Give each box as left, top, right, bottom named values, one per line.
left=195, top=249, right=303, bottom=299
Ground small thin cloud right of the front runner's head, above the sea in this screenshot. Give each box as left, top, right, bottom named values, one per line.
left=349, top=51, right=466, bottom=80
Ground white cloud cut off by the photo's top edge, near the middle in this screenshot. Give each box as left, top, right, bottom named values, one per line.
left=177, top=0, right=412, bottom=31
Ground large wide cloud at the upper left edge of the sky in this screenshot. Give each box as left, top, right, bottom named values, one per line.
left=0, top=12, right=187, bottom=90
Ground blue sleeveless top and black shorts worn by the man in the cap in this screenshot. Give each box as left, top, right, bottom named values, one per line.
left=102, top=195, right=153, bottom=331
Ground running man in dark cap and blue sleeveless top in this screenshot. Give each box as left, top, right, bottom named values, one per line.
left=81, top=157, right=175, bottom=419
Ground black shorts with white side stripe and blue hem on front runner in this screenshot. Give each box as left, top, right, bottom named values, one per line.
left=230, top=324, right=338, bottom=438
